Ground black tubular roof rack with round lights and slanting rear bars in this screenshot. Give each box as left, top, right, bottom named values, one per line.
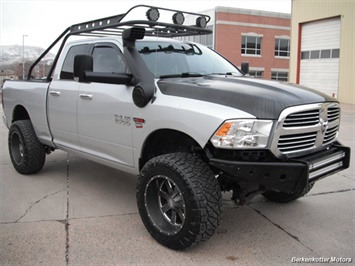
left=27, top=5, right=212, bottom=81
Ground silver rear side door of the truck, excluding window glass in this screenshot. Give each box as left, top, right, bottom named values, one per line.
left=47, top=44, right=90, bottom=150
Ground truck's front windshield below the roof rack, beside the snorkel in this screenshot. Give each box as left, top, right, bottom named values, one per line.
left=136, top=41, right=242, bottom=78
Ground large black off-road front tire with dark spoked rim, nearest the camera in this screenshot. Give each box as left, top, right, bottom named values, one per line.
left=136, top=153, right=222, bottom=250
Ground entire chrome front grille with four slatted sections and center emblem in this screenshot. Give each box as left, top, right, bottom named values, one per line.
left=271, top=103, right=340, bottom=158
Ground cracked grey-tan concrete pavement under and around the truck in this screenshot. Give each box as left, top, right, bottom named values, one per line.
left=0, top=105, right=355, bottom=266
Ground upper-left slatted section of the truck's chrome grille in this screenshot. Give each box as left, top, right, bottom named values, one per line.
left=283, top=110, right=319, bottom=128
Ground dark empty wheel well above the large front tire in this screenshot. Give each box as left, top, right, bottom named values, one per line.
left=139, top=129, right=203, bottom=170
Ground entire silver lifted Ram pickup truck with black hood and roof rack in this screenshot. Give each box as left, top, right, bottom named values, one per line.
left=3, top=6, right=350, bottom=250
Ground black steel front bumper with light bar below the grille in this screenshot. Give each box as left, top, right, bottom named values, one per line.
left=210, top=143, right=350, bottom=193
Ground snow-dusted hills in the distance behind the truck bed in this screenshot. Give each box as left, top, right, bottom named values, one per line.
left=0, top=45, right=55, bottom=67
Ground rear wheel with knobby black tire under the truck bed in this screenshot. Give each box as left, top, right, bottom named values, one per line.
left=8, top=120, right=46, bottom=175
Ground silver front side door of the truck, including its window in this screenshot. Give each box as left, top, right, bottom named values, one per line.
left=77, top=43, right=133, bottom=167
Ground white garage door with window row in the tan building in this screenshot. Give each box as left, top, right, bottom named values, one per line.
left=300, top=18, right=340, bottom=97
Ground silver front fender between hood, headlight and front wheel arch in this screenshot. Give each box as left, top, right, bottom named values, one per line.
left=133, top=90, right=255, bottom=163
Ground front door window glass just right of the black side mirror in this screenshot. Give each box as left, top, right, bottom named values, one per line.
left=92, top=46, right=129, bottom=73
